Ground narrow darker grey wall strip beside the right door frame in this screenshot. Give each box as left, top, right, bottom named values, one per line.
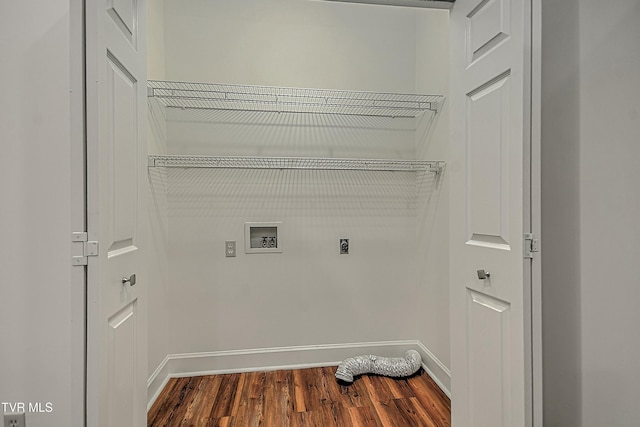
left=541, top=0, right=582, bottom=427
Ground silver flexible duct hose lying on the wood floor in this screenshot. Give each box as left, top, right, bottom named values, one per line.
left=336, top=350, right=422, bottom=383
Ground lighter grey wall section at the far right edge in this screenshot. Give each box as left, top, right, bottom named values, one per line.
left=580, top=0, right=640, bottom=427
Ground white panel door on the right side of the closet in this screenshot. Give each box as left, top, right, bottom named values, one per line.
left=447, top=0, right=531, bottom=427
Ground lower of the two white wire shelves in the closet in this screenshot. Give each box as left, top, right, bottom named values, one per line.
left=148, top=155, right=445, bottom=174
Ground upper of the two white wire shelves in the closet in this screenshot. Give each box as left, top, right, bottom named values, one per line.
left=147, top=80, right=444, bottom=118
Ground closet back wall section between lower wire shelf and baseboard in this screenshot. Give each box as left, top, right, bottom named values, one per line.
left=169, top=169, right=417, bottom=352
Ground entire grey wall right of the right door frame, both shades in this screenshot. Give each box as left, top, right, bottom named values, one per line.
left=542, top=0, right=640, bottom=427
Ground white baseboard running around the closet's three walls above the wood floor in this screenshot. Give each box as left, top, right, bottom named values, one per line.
left=147, top=341, right=451, bottom=408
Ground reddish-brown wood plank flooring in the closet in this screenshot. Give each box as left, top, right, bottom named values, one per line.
left=147, top=367, right=451, bottom=427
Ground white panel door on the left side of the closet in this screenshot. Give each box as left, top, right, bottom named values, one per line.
left=86, top=0, right=147, bottom=427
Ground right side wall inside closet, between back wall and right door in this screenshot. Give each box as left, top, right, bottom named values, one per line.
left=415, top=10, right=451, bottom=378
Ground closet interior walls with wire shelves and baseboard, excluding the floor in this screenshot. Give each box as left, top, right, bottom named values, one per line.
left=147, top=0, right=450, bottom=410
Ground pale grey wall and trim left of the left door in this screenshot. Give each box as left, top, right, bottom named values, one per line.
left=0, top=0, right=84, bottom=427
